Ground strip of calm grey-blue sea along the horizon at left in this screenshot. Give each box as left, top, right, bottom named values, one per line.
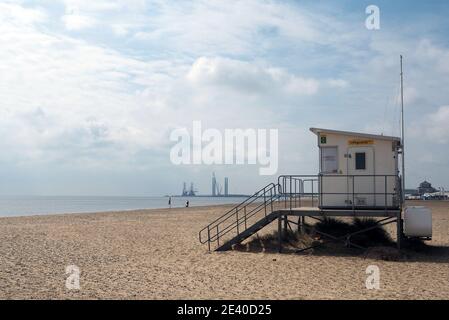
left=0, top=196, right=246, bottom=217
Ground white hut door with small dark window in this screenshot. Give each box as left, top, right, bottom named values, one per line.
left=347, top=147, right=376, bottom=207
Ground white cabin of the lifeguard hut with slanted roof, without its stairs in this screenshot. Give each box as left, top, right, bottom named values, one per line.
left=310, top=128, right=401, bottom=209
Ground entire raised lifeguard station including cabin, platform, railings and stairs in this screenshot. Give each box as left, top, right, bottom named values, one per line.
left=199, top=128, right=432, bottom=251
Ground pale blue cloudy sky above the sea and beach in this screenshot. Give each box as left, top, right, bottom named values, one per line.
left=0, top=0, right=449, bottom=196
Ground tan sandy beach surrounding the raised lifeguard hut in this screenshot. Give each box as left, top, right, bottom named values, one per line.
left=0, top=201, right=449, bottom=299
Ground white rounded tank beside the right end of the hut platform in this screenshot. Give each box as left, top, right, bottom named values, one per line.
left=404, top=206, right=432, bottom=238
